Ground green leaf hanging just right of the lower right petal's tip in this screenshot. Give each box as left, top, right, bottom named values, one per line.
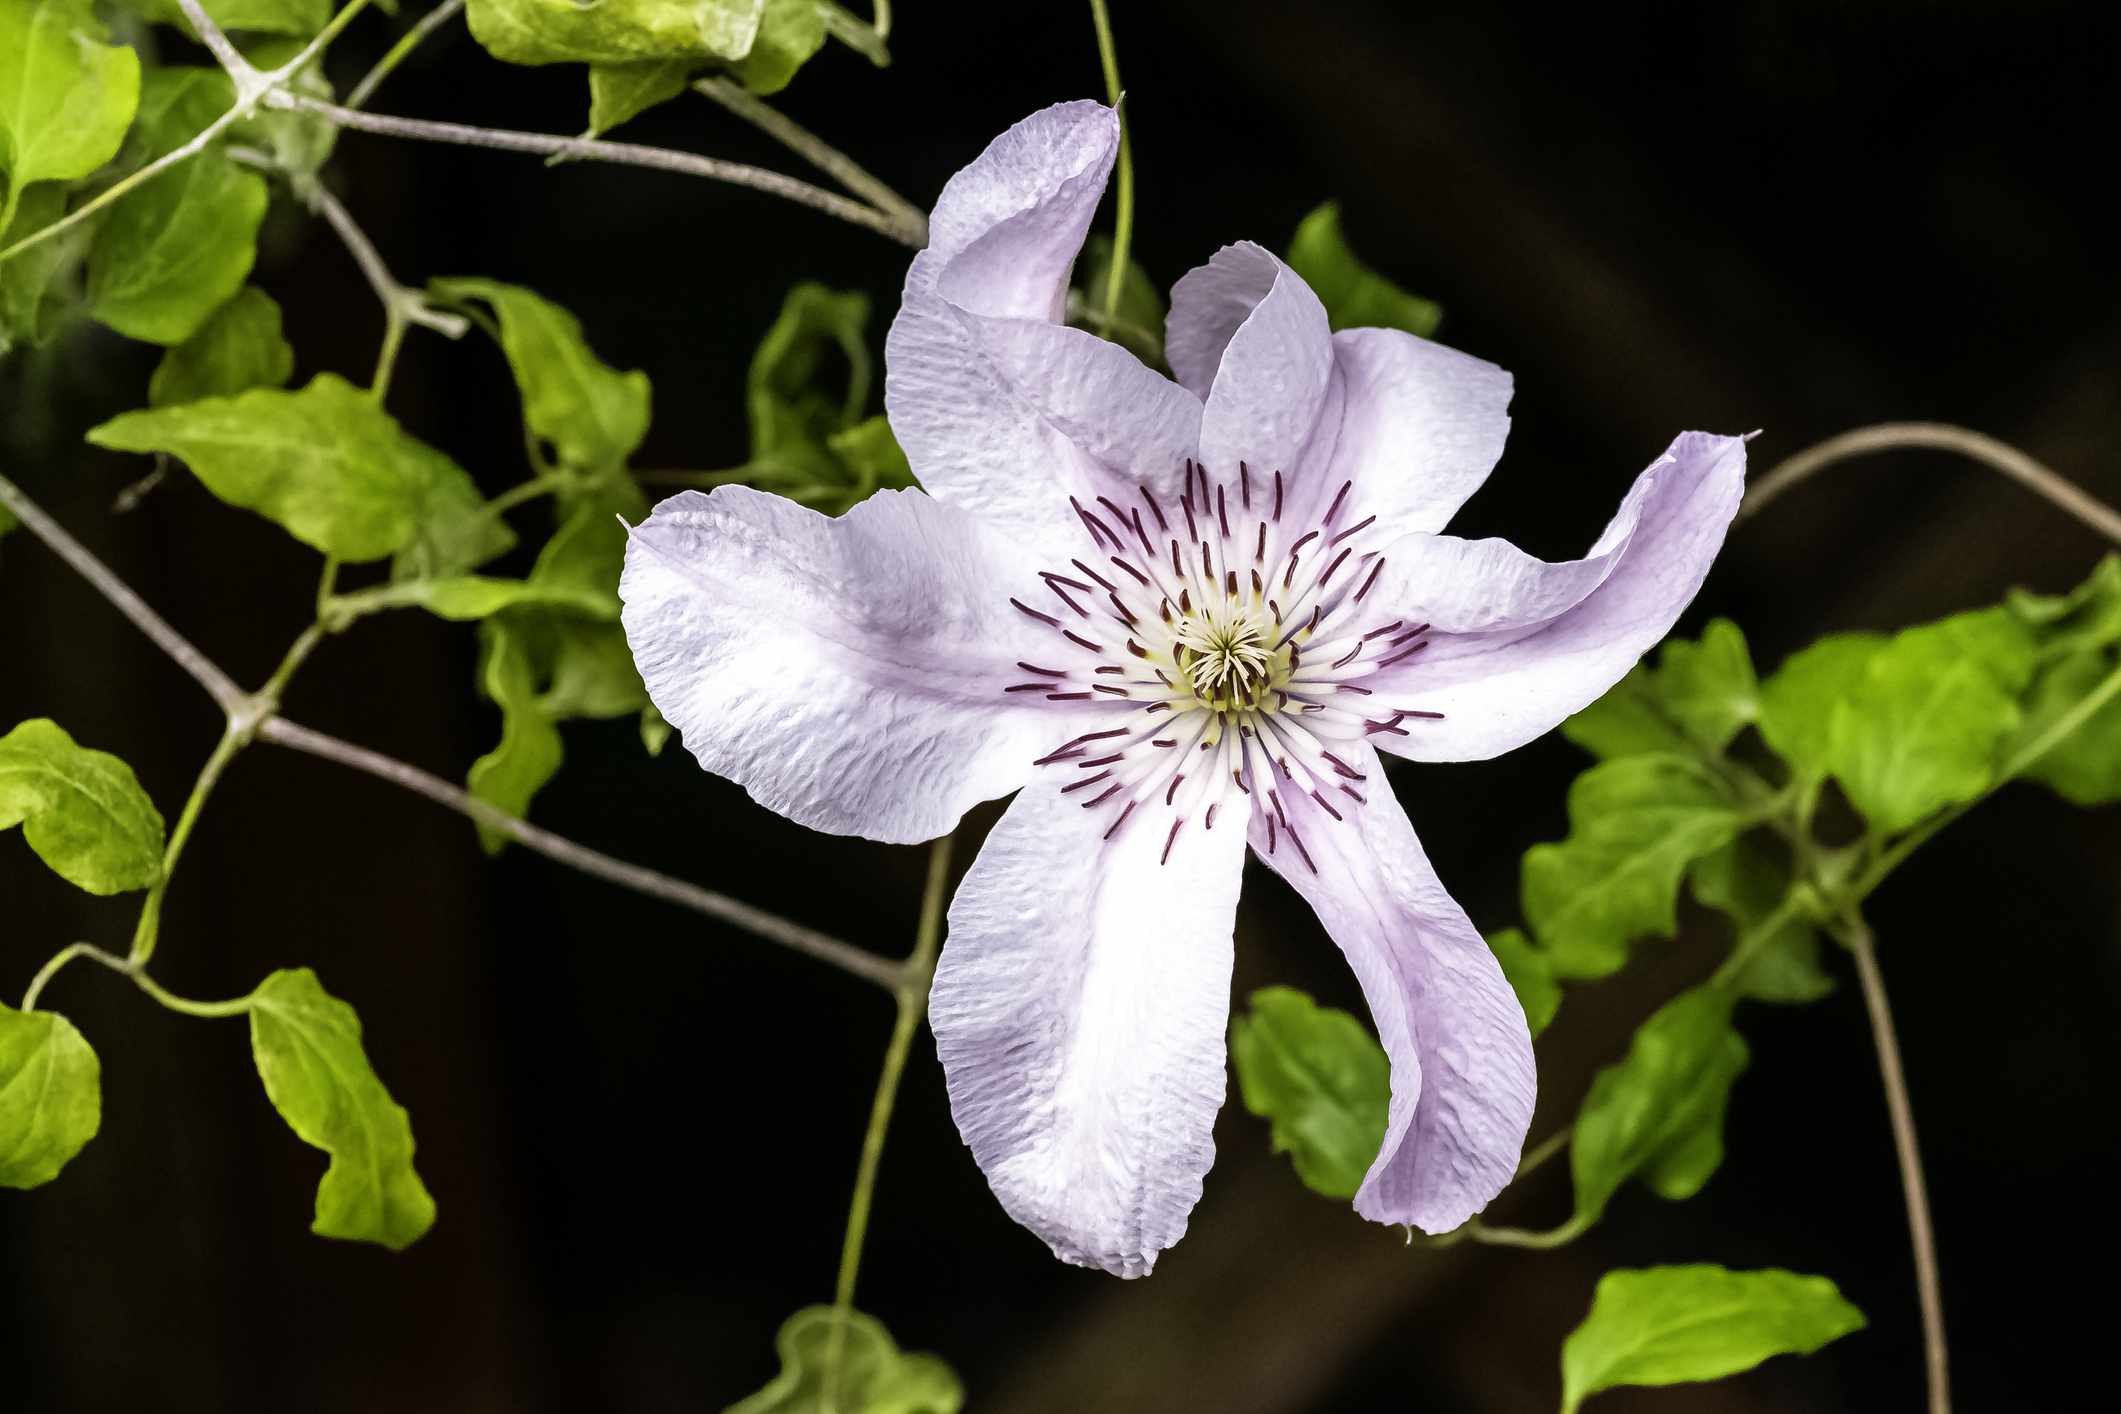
left=1570, top=986, right=1746, bottom=1223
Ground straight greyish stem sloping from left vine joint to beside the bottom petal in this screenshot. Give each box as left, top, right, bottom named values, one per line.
left=259, top=717, right=904, bottom=990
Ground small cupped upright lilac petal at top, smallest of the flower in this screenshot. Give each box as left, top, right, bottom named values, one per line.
left=1164, top=242, right=1334, bottom=477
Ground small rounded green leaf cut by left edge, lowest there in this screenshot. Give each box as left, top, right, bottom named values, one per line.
left=0, top=1000, right=104, bottom=1187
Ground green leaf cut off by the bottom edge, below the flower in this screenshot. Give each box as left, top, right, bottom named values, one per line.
left=723, top=1306, right=965, bottom=1414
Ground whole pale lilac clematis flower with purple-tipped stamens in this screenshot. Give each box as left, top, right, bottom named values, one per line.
left=621, top=102, right=1746, bottom=1276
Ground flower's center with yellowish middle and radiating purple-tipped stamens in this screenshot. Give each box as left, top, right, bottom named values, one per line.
left=1003, top=462, right=1440, bottom=869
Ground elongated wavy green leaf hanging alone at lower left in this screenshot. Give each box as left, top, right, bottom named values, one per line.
left=250, top=967, right=435, bottom=1251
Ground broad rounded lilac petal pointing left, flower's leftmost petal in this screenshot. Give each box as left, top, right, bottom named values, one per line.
left=619, top=485, right=1065, bottom=844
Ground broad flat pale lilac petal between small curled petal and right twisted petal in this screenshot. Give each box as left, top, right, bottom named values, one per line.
left=1326, top=329, right=1510, bottom=534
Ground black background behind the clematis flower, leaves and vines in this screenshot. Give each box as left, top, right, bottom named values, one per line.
left=0, top=0, right=2121, bottom=1414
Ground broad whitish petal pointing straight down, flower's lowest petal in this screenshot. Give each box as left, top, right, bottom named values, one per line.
left=929, top=782, right=1245, bottom=1276
